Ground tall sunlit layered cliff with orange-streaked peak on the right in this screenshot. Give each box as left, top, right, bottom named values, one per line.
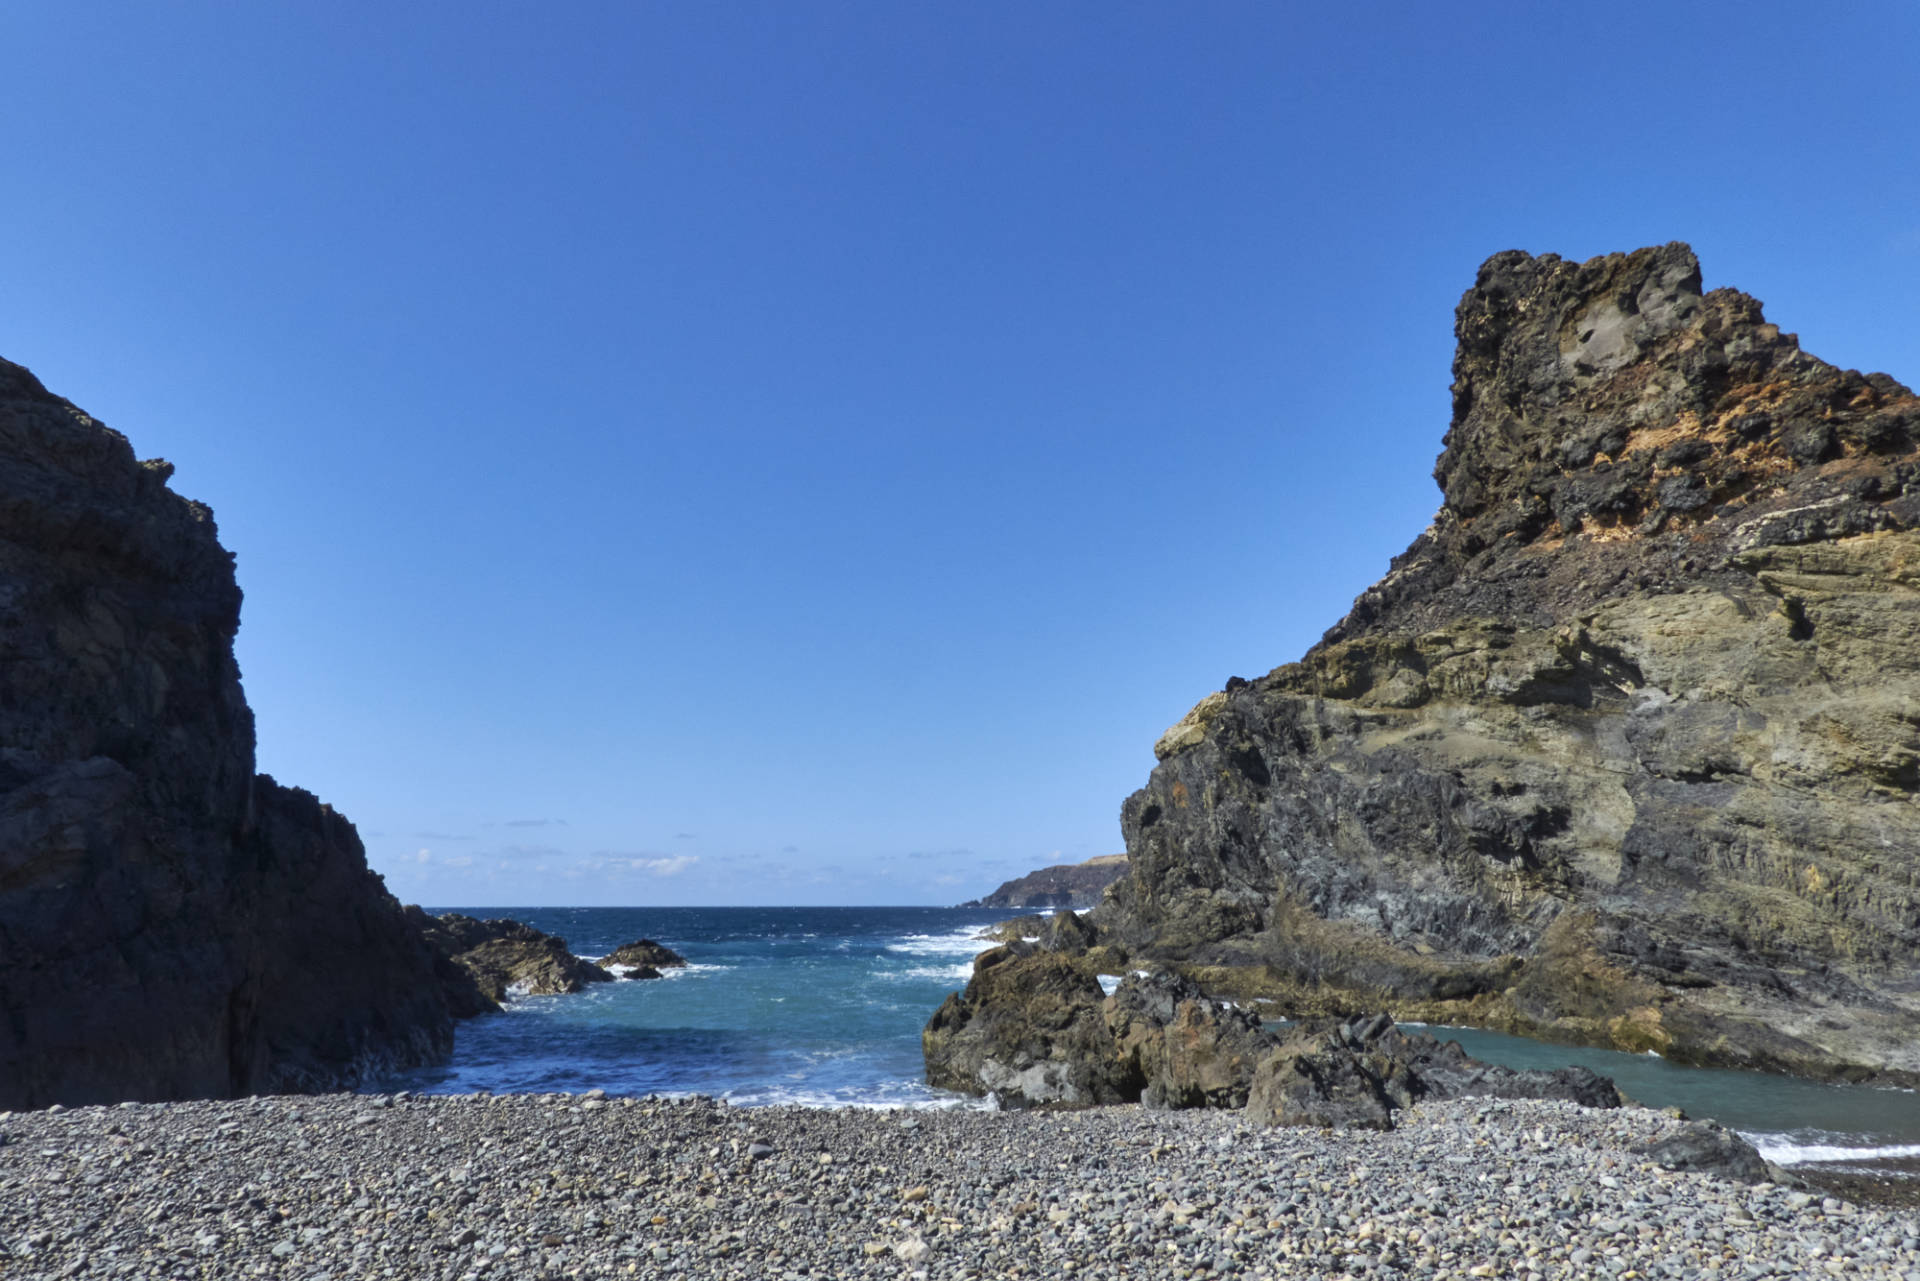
left=1096, top=244, right=1920, bottom=1083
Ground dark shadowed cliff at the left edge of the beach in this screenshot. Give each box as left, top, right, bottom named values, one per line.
left=0, top=361, right=451, bottom=1108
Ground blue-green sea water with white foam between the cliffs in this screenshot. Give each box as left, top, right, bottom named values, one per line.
left=382, top=906, right=1920, bottom=1164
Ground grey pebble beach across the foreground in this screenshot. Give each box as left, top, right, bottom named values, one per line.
left=0, top=1093, right=1920, bottom=1279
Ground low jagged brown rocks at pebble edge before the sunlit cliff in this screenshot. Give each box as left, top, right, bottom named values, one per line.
left=922, top=941, right=1620, bottom=1129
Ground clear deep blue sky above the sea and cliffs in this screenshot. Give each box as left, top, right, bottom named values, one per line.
left=0, top=0, right=1920, bottom=905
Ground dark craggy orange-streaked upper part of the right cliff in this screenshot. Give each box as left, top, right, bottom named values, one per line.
left=1327, top=242, right=1920, bottom=641
